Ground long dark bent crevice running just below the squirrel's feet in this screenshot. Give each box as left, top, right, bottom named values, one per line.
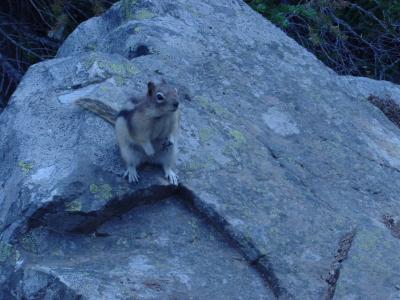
left=8, top=185, right=282, bottom=299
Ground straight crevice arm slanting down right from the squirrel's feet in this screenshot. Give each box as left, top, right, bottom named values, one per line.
left=178, top=185, right=293, bottom=299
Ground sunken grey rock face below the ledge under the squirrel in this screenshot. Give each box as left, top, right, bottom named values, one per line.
left=14, top=199, right=273, bottom=299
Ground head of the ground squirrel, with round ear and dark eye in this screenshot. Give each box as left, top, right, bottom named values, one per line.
left=147, top=79, right=179, bottom=115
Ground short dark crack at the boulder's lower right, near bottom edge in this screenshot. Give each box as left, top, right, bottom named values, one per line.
left=323, top=230, right=356, bottom=300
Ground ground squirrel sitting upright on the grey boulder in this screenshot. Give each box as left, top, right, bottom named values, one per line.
left=76, top=80, right=180, bottom=185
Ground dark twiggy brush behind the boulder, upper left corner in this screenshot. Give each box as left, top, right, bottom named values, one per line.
left=0, top=0, right=116, bottom=108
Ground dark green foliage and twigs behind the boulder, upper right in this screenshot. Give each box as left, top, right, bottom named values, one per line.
left=246, top=0, right=400, bottom=83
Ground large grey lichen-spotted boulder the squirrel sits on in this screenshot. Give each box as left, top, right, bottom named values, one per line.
left=0, top=0, right=400, bottom=299
